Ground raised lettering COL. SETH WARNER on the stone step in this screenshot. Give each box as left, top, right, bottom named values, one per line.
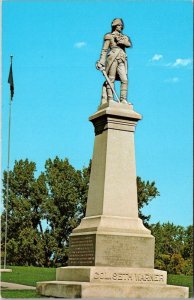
left=93, top=272, right=165, bottom=283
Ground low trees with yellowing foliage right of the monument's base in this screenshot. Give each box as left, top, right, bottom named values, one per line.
left=151, top=222, right=193, bottom=275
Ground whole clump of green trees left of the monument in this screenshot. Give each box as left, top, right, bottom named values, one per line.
left=2, top=157, right=87, bottom=266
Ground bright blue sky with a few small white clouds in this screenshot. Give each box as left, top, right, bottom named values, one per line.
left=1, top=0, right=193, bottom=226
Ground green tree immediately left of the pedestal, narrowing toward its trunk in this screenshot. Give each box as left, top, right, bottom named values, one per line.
left=44, top=157, right=85, bottom=264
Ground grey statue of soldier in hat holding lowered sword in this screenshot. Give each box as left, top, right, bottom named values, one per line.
left=96, top=19, right=132, bottom=104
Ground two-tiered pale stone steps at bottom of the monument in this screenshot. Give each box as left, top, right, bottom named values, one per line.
left=37, top=267, right=189, bottom=298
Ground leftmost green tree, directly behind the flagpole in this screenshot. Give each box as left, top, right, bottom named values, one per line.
left=2, top=159, right=47, bottom=264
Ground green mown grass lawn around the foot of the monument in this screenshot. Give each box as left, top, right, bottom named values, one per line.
left=1, top=267, right=193, bottom=298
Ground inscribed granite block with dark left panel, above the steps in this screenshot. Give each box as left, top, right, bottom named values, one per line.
left=68, top=231, right=155, bottom=268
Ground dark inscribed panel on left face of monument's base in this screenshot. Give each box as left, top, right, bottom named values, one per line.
left=68, top=235, right=95, bottom=266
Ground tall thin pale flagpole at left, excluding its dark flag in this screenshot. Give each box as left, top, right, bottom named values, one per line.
left=4, top=55, right=13, bottom=269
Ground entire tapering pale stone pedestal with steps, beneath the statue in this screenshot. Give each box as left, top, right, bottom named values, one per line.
left=37, top=101, right=188, bottom=298
